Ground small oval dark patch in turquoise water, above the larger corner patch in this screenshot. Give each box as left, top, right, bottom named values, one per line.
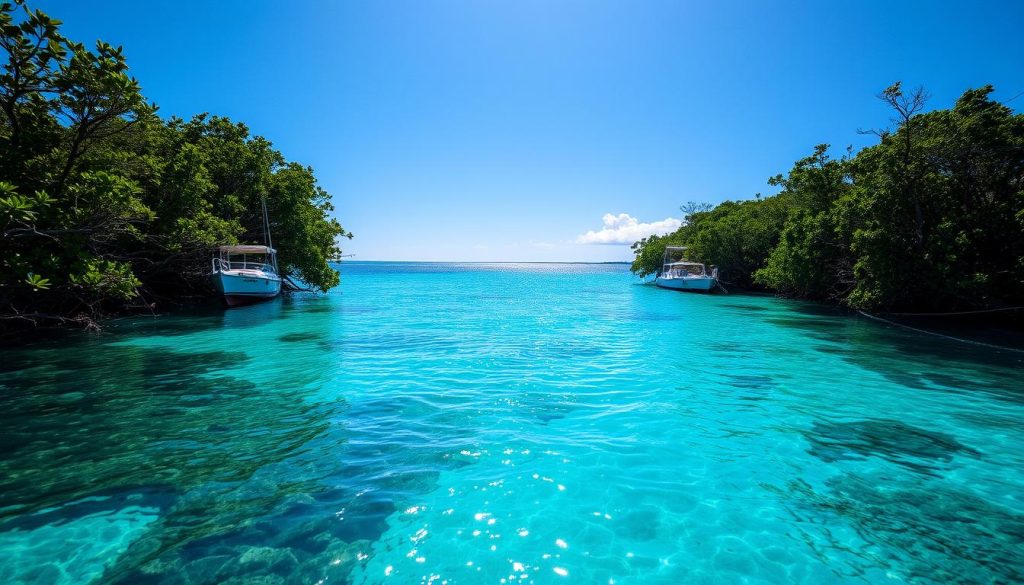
left=804, top=420, right=981, bottom=472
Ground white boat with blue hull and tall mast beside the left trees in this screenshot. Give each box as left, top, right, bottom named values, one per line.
left=213, top=202, right=281, bottom=306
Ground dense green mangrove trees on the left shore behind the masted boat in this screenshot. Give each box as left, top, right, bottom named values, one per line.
left=0, top=3, right=351, bottom=324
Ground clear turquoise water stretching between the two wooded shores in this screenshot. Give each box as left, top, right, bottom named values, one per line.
left=0, top=262, right=1024, bottom=585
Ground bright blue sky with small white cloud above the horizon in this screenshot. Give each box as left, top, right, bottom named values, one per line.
left=33, top=0, right=1024, bottom=261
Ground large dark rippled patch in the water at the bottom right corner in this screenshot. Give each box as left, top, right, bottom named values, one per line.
left=768, top=473, right=1024, bottom=585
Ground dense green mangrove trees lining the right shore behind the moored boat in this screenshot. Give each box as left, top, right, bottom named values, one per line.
left=633, top=83, right=1024, bottom=310
